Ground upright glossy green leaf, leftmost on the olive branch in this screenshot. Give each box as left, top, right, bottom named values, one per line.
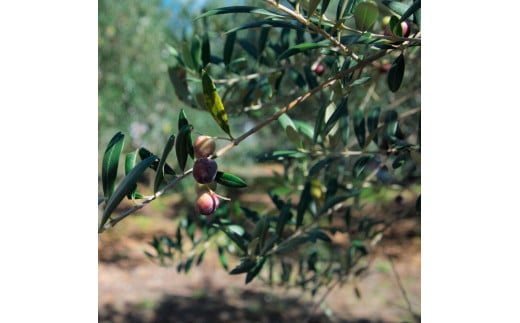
left=101, top=132, right=125, bottom=200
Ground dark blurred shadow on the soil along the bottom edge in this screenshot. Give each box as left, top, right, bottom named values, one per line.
left=98, top=291, right=390, bottom=323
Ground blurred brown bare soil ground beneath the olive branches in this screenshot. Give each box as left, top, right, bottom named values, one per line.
left=98, top=191, right=421, bottom=323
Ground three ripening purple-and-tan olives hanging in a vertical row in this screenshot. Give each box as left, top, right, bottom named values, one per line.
left=193, top=136, right=220, bottom=215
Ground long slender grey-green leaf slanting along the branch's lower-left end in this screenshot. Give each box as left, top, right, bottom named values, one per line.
left=99, top=156, right=157, bottom=232
